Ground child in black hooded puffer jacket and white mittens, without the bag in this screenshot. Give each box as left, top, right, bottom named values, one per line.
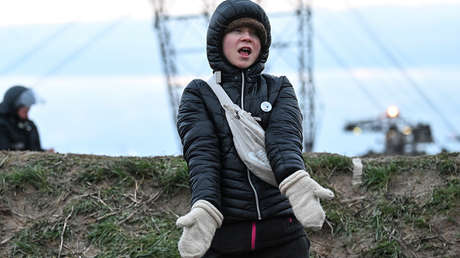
left=176, top=0, right=333, bottom=258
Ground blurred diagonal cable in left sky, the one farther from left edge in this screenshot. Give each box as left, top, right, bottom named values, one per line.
left=32, top=17, right=125, bottom=88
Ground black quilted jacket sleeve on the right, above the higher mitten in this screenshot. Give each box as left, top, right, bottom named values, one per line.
left=265, top=76, right=305, bottom=183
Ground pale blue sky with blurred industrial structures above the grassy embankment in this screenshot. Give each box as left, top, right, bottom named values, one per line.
left=0, top=0, right=460, bottom=156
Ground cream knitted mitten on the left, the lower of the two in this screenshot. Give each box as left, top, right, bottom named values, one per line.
left=176, top=200, right=224, bottom=258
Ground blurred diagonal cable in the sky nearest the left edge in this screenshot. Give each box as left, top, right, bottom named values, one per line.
left=0, top=22, right=75, bottom=75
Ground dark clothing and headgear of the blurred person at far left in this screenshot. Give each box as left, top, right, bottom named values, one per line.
left=0, top=86, right=43, bottom=151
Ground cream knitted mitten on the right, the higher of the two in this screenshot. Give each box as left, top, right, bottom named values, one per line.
left=279, top=170, right=334, bottom=230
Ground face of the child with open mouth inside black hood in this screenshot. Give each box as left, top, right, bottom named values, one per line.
left=222, top=27, right=261, bottom=69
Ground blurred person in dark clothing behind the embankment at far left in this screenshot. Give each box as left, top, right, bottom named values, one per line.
left=0, top=86, right=53, bottom=152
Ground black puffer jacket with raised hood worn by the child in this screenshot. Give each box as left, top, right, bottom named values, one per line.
left=177, top=0, right=305, bottom=222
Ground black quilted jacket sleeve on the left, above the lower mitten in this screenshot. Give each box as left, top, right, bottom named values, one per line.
left=177, top=80, right=221, bottom=210
